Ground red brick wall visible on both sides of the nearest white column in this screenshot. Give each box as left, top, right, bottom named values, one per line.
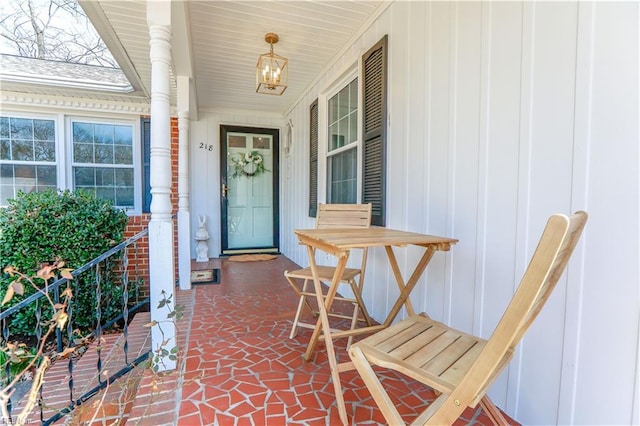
left=125, top=117, right=178, bottom=297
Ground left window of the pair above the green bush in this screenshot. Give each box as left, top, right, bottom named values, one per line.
left=0, top=117, right=57, bottom=206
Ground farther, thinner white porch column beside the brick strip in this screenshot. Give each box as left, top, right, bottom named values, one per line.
left=178, top=76, right=191, bottom=290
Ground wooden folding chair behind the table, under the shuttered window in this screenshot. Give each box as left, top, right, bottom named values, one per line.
left=284, top=204, right=372, bottom=344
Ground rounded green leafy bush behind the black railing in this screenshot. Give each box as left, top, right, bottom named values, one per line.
left=0, top=190, right=127, bottom=335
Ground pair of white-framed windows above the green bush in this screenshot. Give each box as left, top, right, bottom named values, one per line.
left=0, top=115, right=142, bottom=211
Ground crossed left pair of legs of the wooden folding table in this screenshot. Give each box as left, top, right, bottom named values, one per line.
left=304, top=246, right=349, bottom=426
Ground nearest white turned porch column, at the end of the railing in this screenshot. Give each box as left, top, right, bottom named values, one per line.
left=147, top=1, right=177, bottom=371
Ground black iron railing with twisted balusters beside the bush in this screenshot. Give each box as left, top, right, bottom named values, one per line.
left=0, top=229, right=150, bottom=425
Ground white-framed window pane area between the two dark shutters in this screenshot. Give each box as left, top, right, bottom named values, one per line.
left=327, top=78, right=358, bottom=204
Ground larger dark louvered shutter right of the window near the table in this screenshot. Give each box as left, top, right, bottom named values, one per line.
left=362, top=35, right=387, bottom=226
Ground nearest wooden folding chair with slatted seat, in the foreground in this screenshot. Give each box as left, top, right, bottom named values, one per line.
left=349, top=212, right=587, bottom=425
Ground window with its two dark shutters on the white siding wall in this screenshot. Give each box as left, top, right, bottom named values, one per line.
left=309, top=35, right=387, bottom=226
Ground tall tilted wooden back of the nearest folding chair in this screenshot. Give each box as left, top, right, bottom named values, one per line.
left=448, top=212, right=587, bottom=412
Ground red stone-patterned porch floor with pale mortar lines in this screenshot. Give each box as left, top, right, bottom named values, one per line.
left=138, top=256, right=517, bottom=426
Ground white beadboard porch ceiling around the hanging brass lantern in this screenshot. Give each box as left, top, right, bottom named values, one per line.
left=89, top=0, right=387, bottom=115
